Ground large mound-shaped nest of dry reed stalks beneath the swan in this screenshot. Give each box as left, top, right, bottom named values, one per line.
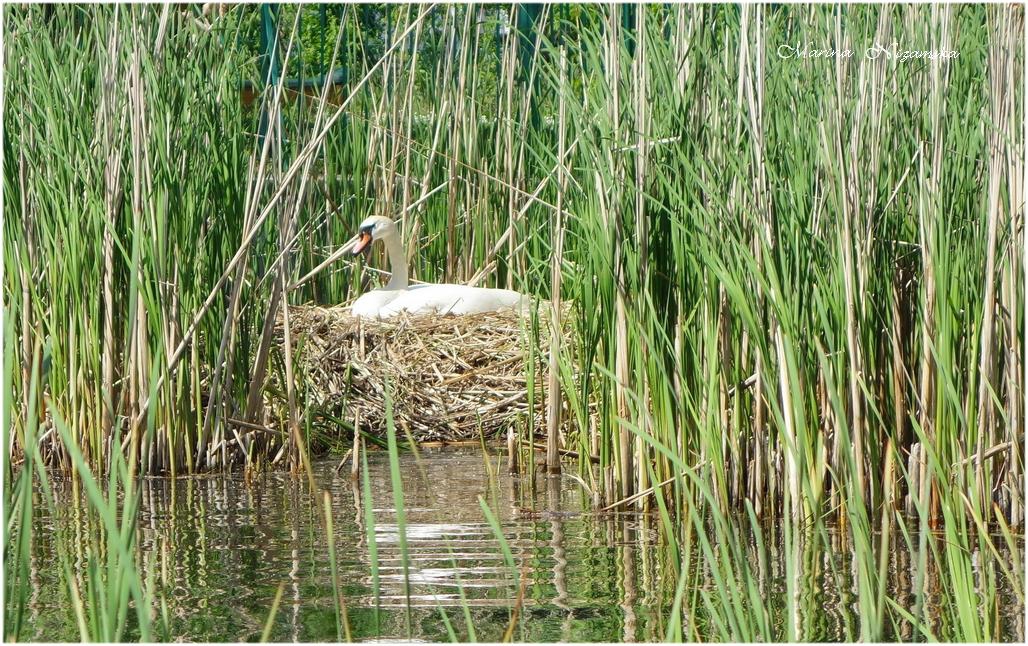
left=276, top=306, right=566, bottom=442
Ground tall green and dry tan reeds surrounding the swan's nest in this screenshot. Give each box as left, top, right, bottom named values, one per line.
left=3, top=4, right=1026, bottom=640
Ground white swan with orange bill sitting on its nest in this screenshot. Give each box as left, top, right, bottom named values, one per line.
left=350, top=215, right=527, bottom=319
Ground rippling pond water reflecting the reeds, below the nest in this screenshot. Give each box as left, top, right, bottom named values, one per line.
left=22, top=448, right=1024, bottom=642
